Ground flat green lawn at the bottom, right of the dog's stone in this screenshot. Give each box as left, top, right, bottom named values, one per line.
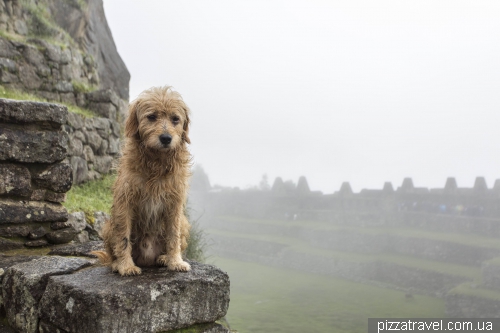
left=212, top=257, right=445, bottom=333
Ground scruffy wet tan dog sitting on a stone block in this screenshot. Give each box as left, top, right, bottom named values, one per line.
left=94, top=87, right=191, bottom=275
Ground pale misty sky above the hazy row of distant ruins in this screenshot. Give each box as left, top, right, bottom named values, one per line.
left=104, top=0, right=500, bottom=193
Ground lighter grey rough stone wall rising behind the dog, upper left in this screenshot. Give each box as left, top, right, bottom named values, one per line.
left=0, top=0, right=130, bottom=184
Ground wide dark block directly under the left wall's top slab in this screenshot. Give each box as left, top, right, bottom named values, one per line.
left=0, top=127, right=69, bottom=163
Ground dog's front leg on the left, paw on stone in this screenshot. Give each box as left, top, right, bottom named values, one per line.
left=111, top=207, right=141, bottom=276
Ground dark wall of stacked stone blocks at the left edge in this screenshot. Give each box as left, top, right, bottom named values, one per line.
left=0, top=99, right=77, bottom=251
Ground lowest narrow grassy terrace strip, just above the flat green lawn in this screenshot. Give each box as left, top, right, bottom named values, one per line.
left=206, top=228, right=481, bottom=282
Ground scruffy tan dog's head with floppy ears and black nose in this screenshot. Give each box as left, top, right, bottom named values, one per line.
left=125, top=86, right=191, bottom=151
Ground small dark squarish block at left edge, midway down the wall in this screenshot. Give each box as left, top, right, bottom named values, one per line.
left=0, top=164, right=31, bottom=197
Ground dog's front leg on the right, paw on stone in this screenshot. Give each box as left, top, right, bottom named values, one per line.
left=157, top=210, right=191, bottom=272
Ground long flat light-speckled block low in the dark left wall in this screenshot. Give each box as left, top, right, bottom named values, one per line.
left=0, top=199, right=68, bottom=224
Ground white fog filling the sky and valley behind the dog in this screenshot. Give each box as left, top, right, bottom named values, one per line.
left=104, top=0, right=500, bottom=332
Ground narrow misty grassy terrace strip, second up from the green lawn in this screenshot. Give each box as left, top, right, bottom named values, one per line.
left=218, top=216, right=500, bottom=249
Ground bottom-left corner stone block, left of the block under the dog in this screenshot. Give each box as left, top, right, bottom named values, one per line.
left=2, top=256, right=91, bottom=333
